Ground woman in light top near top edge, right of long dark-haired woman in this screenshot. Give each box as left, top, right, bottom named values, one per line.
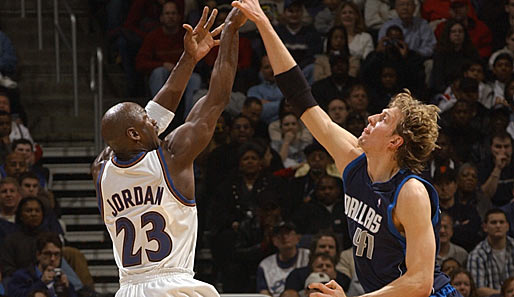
left=335, top=1, right=375, bottom=77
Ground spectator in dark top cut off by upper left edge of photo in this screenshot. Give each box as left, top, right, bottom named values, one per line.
left=0, top=31, right=18, bottom=89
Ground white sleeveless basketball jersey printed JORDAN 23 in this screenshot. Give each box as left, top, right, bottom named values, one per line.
left=96, top=148, right=198, bottom=279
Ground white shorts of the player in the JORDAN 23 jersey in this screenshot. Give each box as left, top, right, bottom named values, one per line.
left=115, top=272, right=220, bottom=297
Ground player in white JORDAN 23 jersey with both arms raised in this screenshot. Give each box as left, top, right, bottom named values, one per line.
left=92, top=7, right=246, bottom=297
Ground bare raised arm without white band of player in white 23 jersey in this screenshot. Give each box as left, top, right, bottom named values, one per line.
left=164, top=8, right=246, bottom=166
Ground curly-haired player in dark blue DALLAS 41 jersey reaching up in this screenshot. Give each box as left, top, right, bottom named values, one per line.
left=232, top=0, right=460, bottom=297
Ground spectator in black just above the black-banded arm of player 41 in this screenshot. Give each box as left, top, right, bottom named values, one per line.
left=312, top=52, right=356, bottom=106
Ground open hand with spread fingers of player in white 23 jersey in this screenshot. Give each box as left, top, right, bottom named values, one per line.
left=182, top=6, right=223, bottom=62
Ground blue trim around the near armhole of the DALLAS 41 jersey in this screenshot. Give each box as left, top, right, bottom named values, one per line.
left=387, top=174, right=439, bottom=254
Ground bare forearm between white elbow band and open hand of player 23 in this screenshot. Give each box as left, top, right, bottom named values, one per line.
left=153, top=52, right=196, bottom=112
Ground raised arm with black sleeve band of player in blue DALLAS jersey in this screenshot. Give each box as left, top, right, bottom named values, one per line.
left=232, top=0, right=361, bottom=172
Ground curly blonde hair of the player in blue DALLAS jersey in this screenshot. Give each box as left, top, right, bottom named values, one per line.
left=389, top=89, right=439, bottom=174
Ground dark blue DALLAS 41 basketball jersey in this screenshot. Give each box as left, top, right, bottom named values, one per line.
left=343, top=154, right=450, bottom=293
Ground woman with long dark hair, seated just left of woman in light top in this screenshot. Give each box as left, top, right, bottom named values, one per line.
left=314, top=26, right=350, bottom=82
